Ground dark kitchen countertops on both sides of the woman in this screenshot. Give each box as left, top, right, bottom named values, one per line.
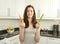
left=0, top=28, right=60, bottom=40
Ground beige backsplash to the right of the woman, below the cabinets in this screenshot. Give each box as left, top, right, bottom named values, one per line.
left=40, top=20, right=60, bottom=31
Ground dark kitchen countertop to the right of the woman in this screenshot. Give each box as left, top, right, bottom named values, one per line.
left=40, top=30, right=60, bottom=38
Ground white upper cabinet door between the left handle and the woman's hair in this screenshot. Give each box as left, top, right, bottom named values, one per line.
left=10, top=0, right=25, bottom=17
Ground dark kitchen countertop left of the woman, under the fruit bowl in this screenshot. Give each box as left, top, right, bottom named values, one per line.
left=0, top=28, right=19, bottom=40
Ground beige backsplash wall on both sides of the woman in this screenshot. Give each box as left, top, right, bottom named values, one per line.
left=0, top=19, right=60, bottom=30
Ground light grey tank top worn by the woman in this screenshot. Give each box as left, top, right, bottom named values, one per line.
left=20, top=28, right=37, bottom=44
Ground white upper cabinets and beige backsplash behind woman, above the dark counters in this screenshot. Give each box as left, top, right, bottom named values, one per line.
left=0, top=0, right=60, bottom=30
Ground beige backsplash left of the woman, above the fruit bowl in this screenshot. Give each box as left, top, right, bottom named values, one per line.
left=0, top=19, right=19, bottom=30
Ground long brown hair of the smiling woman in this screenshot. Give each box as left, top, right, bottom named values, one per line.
left=24, top=5, right=37, bottom=28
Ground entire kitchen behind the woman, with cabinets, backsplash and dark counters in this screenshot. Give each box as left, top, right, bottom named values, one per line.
left=0, top=0, right=60, bottom=44
